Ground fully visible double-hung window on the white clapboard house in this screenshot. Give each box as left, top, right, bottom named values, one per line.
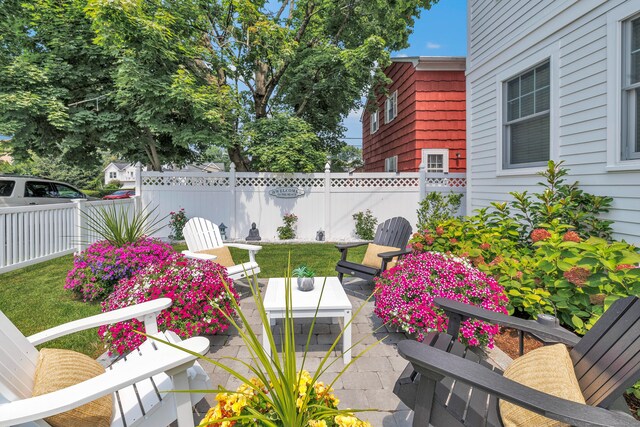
left=503, top=61, right=551, bottom=169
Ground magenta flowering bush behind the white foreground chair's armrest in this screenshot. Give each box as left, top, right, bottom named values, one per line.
left=98, top=253, right=238, bottom=354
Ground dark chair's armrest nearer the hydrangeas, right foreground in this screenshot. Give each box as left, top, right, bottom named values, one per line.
left=433, top=297, right=580, bottom=347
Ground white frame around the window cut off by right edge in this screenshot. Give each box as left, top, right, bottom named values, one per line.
left=606, top=2, right=640, bottom=172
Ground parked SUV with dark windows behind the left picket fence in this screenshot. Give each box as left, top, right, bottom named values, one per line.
left=0, top=174, right=95, bottom=207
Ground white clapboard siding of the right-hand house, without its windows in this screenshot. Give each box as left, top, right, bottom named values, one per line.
left=467, top=0, right=640, bottom=243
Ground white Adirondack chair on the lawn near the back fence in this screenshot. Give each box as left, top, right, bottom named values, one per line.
left=182, top=217, right=262, bottom=284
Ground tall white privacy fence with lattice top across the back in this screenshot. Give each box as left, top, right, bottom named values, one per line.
left=136, top=167, right=466, bottom=241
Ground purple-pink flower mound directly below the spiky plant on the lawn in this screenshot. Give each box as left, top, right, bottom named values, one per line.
left=64, top=237, right=175, bottom=301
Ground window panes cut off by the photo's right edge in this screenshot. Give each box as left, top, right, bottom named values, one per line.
left=622, top=16, right=640, bottom=160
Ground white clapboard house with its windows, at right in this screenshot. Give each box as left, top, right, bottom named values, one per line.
left=467, top=0, right=640, bottom=244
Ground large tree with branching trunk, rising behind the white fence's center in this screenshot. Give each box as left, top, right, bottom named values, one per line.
left=88, top=0, right=437, bottom=171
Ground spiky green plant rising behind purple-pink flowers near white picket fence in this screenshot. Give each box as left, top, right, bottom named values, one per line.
left=82, top=203, right=166, bottom=247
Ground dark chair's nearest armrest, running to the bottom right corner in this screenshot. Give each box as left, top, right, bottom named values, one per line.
left=398, top=340, right=638, bottom=427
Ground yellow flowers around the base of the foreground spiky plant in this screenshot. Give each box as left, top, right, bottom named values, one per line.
left=198, top=371, right=371, bottom=427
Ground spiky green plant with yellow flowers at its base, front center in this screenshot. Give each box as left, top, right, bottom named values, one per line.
left=154, top=261, right=377, bottom=427
